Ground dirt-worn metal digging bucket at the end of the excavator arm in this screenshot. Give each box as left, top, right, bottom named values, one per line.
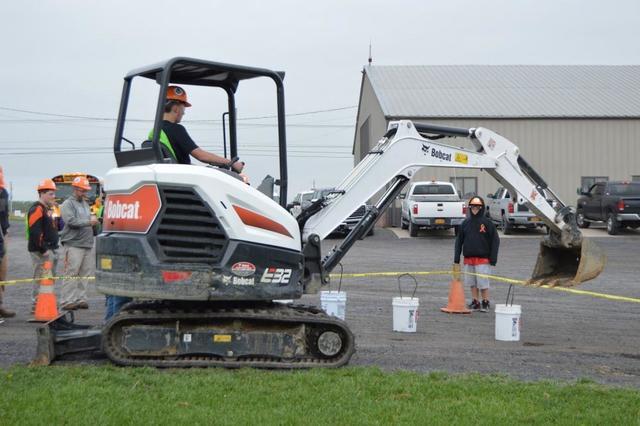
left=527, top=239, right=607, bottom=287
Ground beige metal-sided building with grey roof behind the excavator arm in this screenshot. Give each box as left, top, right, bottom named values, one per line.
left=353, top=65, right=640, bottom=225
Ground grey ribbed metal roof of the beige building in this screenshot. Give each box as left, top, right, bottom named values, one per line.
left=364, top=65, right=640, bottom=118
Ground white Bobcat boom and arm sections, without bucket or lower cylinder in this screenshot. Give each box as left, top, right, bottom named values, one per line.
left=302, top=121, right=564, bottom=241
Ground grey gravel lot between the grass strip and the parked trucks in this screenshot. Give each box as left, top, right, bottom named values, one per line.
left=0, top=222, right=640, bottom=388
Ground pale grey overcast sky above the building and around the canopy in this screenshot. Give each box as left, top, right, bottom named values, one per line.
left=0, top=0, right=640, bottom=200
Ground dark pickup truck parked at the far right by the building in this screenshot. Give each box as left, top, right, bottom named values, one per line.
left=576, top=181, right=640, bottom=235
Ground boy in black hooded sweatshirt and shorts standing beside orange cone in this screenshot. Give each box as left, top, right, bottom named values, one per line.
left=453, top=196, right=500, bottom=312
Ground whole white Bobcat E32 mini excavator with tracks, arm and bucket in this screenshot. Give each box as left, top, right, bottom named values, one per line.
left=37, top=58, right=605, bottom=368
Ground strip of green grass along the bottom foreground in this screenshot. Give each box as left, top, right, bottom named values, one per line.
left=0, top=366, right=640, bottom=425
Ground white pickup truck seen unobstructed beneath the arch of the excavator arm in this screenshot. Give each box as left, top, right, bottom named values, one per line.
left=400, top=181, right=467, bottom=237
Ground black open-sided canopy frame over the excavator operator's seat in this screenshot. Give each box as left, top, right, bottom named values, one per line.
left=113, top=57, right=287, bottom=207
